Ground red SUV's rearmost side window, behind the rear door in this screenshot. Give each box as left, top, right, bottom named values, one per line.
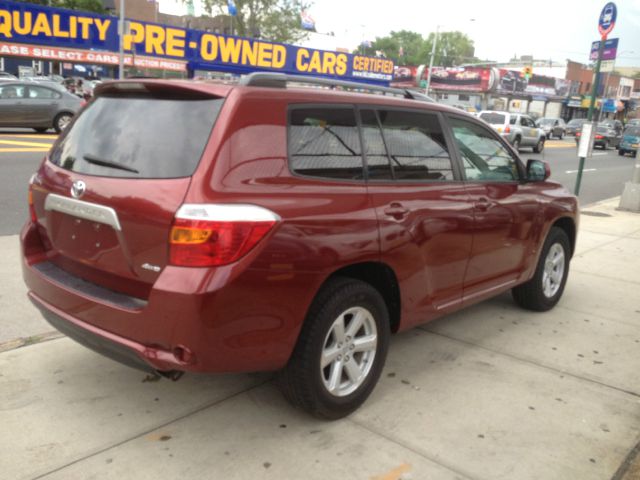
left=289, top=108, right=363, bottom=180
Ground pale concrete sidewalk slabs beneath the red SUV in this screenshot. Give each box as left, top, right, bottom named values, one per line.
left=0, top=199, right=640, bottom=480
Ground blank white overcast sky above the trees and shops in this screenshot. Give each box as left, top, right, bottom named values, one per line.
left=309, top=0, right=640, bottom=66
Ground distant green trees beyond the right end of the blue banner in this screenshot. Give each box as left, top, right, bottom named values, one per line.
left=358, top=30, right=476, bottom=67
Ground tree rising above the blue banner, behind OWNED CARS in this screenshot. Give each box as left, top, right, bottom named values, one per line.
left=198, top=0, right=310, bottom=43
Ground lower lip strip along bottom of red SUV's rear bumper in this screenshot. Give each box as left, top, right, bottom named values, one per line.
left=28, top=292, right=186, bottom=373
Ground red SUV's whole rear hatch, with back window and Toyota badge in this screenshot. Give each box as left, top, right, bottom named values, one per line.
left=32, top=82, right=229, bottom=298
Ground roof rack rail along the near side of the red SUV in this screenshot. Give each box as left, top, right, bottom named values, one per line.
left=239, top=72, right=435, bottom=103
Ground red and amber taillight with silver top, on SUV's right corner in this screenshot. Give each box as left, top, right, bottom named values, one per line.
left=169, top=204, right=280, bottom=267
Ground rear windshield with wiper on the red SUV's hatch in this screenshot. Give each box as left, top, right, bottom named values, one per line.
left=50, top=97, right=223, bottom=178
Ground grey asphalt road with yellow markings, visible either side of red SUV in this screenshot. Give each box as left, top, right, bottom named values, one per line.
left=0, top=129, right=634, bottom=235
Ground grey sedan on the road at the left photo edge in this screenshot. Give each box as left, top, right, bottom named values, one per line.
left=0, top=81, right=83, bottom=133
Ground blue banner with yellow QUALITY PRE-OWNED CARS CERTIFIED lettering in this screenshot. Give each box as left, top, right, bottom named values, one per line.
left=0, top=0, right=394, bottom=85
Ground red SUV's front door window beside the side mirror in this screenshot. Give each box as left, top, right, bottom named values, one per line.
left=450, top=118, right=519, bottom=182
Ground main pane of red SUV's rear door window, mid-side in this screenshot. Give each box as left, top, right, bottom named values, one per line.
left=378, top=110, right=453, bottom=180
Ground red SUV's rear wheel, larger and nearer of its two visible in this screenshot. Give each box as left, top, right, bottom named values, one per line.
left=278, top=278, right=390, bottom=420
